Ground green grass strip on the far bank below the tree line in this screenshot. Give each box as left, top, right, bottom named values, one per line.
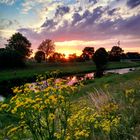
left=0, top=62, right=140, bottom=82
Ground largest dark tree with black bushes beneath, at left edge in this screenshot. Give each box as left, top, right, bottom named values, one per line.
left=0, top=33, right=32, bottom=68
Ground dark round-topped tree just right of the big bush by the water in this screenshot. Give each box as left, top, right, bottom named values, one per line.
left=109, top=46, right=124, bottom=61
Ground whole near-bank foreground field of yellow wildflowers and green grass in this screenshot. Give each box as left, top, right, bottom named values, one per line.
left=0, top=65, right=140, bottom=140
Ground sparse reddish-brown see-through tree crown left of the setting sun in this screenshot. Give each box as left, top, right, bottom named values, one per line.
left=38, top=39, right=55, bottom=59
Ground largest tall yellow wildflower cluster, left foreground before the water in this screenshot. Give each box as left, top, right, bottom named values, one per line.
left=0, top=74, right=77, bottom=140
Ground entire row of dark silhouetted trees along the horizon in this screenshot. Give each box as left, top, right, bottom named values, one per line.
left=0, top=33, right=140, bottom=68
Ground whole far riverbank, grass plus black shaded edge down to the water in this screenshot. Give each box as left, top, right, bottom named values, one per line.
left=0, top=61, right=140, bottom=97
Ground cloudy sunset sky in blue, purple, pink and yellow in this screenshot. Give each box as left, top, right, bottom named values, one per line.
left=0, top=0, right=140, bottom=54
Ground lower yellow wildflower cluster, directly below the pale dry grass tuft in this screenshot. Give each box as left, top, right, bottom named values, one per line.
left=68, top=103, right=121, bottom=140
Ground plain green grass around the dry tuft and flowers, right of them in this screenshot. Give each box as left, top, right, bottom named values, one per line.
left=74, top=69, right=140, bottom=140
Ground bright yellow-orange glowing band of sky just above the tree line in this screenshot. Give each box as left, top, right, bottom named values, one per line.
left=30, top=39, right=140, bottom=59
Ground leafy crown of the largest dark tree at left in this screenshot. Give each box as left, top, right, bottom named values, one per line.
left=6, top=33, right=32, bottom=60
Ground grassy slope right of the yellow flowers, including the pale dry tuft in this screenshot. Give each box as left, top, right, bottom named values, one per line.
left=79, top=71, right=140, bottom=140
